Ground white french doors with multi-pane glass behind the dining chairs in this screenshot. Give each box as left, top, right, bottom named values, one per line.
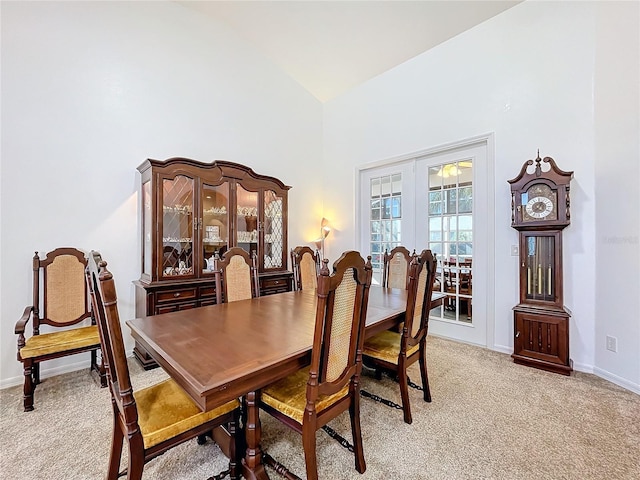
left=358, top=139, right=493, bottom=345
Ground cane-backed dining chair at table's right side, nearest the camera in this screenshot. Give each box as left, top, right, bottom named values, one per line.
left=260, top=251, right=372, bottom=480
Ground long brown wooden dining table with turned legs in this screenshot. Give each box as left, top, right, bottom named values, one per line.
left=126, top=286, right=441, bottom=479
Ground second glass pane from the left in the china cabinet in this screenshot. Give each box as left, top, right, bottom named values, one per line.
left=202, top=183, right=229, bottom=273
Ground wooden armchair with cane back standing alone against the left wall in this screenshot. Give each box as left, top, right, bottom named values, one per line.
left=14, top=248, right=107, bottom=412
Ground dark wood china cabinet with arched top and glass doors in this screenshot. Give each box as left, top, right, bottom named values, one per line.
left=134, top=158, right=293, bottom=368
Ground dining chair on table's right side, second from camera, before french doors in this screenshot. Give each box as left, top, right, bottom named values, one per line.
left=363, top=250, right=436, bottom=423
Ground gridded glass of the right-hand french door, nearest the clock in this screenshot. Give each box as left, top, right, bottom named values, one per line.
left=428, top=160, right=473, bottom=323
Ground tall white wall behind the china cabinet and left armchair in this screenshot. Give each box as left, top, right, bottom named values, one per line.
left=0, top=2, right=322, bottom=386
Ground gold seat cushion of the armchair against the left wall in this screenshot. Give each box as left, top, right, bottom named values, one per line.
left=20, top=325, right=100, bottom=359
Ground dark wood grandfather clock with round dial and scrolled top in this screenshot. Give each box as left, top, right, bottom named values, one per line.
left=509, top=154, right=573, bottom=375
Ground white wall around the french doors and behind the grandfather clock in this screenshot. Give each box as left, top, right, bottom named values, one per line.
left=323, top=2, right=640, bottom=391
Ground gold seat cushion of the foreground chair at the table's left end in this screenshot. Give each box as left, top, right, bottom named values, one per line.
left=133, top=379, right=240, bottom=448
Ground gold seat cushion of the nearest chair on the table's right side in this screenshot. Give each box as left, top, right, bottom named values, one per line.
left=261, top=367, right=349, bottom=424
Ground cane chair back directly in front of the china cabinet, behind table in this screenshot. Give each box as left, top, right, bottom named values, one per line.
left=214, top=247, right=260, bottom=304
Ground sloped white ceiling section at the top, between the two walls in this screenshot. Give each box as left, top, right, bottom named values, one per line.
left=177, top=0, right=520, bottom=102
